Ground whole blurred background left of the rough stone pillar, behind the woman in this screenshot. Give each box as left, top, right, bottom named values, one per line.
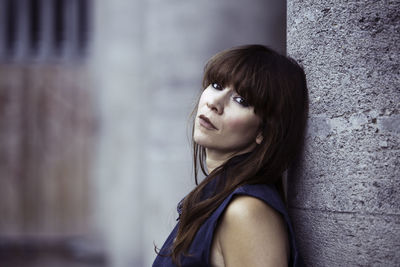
left=0, top=0, right=286, bottom=267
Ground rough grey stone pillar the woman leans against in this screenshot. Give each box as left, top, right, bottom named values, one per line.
left=287, top=0, right=400, bottom=266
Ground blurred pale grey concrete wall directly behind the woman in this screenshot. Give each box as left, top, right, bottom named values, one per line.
left=91, top=0, right=285, bottom=267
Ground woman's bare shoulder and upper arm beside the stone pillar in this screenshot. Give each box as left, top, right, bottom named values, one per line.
left=215, top=196, right=289, bottom=266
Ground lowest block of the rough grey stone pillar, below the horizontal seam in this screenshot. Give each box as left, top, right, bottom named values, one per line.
left=290, top=209, right=400, bottom=266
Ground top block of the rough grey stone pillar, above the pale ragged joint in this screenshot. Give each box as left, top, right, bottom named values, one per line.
left=287, top=0, right=400, bottom=117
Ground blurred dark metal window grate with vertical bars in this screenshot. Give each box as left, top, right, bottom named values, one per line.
left=0, top=0, right=91, bottom=61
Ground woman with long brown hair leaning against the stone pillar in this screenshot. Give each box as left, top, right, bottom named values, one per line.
left=153, top=45, right=308, bottom=267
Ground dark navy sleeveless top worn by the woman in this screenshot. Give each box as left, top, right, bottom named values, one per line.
left=153, top=158, right=304, bottom=267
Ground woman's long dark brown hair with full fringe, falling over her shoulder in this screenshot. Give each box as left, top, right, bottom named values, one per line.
left=171, top=45, right=308, bottom=265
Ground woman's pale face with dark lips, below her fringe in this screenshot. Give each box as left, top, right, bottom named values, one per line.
left=193, top=83, right=262, bottom=158
